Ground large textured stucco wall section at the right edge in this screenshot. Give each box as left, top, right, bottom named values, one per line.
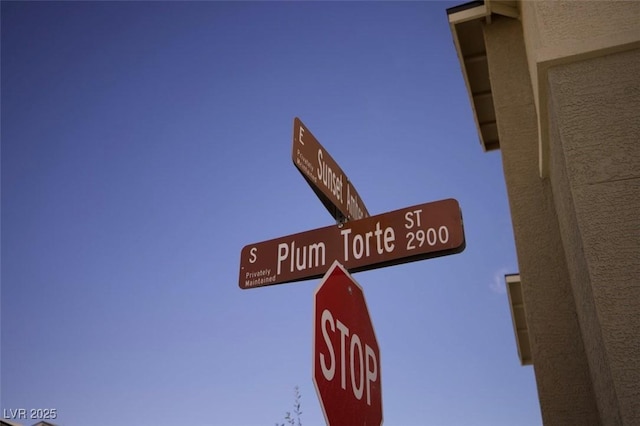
left=548, top=50, right=640, bottom=425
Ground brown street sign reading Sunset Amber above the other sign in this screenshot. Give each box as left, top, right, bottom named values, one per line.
left=291, top=117, right=369, bottom=222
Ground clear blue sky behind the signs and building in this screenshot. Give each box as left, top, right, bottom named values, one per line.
left=1, top=1, right=541, bottom=426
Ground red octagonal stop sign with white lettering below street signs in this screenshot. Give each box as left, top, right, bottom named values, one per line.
left=313, top=261, right=382, bottom=426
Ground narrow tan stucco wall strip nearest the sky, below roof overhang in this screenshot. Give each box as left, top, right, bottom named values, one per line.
left=484, top=17, right=600, bottom=425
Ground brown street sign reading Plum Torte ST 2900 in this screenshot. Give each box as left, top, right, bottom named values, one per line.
left=239, top=198, right=465, bottom=289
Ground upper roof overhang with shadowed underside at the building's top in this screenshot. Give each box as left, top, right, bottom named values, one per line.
left=447, top=0, right=519, bottom=151
